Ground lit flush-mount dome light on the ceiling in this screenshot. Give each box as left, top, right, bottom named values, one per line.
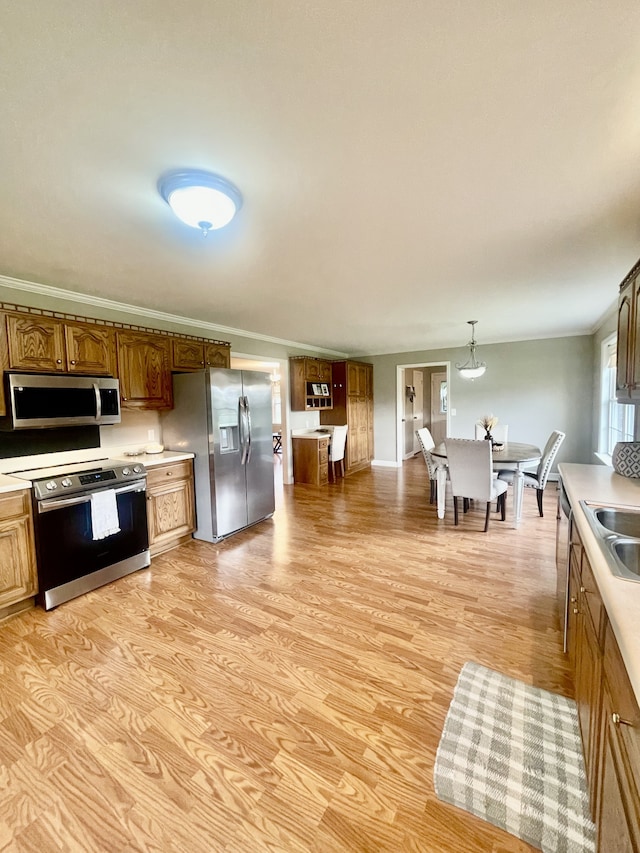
left=158, top=169, right=242, bottom=237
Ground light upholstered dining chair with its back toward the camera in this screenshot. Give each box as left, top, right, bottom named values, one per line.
left=444, top=438, right=509, bottom=533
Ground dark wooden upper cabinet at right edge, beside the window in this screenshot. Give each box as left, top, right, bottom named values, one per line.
left=616, top=262, right=640, bottom=404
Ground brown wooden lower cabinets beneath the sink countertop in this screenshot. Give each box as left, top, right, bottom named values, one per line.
left=568, top=526, right=640, bottom=853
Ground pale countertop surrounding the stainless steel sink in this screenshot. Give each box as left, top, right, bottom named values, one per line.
left=558, top=462, right=640, bottom=703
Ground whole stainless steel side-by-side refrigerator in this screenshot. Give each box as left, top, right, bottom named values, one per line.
left=161, top=368, right=275, bottom=542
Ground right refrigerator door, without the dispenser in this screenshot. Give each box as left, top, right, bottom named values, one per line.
left=242, top=370, right=275, bottom=524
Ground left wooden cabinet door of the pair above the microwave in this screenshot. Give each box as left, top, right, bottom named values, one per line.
left=7, top=314, right=66, bottom=373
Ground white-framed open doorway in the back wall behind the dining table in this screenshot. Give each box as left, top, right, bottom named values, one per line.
left=396, top=362, right=450, bottom=465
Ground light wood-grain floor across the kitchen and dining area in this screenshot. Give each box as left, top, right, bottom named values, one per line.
left=0, top=457, right=573, bottom=853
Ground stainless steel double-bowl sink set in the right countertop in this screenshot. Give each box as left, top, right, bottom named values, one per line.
left=580, top=501, right=640, bottom=583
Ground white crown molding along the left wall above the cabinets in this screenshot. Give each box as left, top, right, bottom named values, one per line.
left=0, top=275, right=348, bottom=358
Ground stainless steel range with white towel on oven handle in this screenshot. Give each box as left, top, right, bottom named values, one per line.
left=12, top=459, right=151, bottom=610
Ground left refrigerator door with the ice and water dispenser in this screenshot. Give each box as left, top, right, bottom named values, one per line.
left=207, top=369, right=250, bottom=539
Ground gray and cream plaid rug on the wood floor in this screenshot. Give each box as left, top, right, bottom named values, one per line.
left=434, top=663, right=595, bottom=853
